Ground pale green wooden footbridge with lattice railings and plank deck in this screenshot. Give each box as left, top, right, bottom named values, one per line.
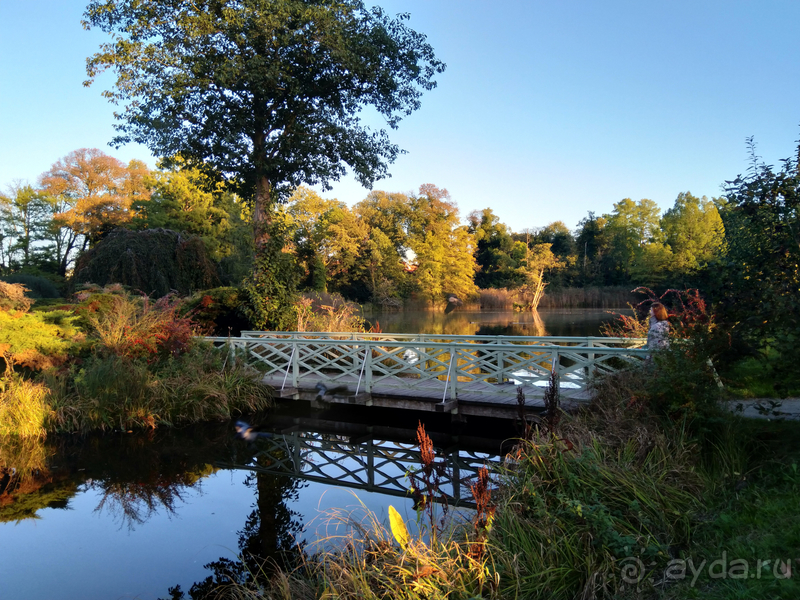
left=206, top=331, right=649, bottom=418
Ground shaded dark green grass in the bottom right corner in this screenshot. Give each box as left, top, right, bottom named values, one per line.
left=665, top=420, right=800, bottom=600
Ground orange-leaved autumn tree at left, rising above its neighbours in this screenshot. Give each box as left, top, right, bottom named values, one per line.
left=40, top=148, right=150, bottom=275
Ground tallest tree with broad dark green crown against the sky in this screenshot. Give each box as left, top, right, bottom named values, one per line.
left=84, top=0, right=444, bottom=242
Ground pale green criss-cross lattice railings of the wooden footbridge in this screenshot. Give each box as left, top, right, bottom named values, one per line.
left=206, top=332, right=649, bottom=401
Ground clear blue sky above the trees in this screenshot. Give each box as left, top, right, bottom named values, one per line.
left=0, top=0, right=800, bottom=231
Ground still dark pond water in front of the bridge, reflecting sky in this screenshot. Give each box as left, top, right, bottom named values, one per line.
left=0, top=405, right=516, bottom=600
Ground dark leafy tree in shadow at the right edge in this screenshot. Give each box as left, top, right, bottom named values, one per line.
left=714, top=139, right=800, bottom=391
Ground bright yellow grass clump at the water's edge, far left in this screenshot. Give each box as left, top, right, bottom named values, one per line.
left=0, top=371, right=50, bottom=438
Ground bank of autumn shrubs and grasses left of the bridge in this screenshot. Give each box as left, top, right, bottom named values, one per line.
left=0, top=286, right=272, bottom=437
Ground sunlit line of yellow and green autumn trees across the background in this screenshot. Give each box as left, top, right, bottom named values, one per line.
left=0, top=149, right=725, bottom=308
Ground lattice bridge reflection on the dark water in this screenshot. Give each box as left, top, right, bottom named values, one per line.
left=218, top=421, right=501, bottom=508
